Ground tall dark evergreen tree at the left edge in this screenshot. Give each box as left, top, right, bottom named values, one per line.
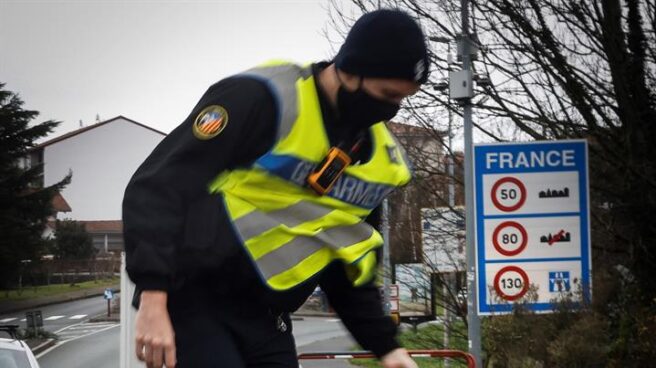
left=0, top=83, right=71, bottom=288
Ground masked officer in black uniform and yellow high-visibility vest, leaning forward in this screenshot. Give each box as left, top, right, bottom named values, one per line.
left=123, top=10, right=428, bottom=368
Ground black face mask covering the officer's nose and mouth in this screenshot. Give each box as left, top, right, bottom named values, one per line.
left=337, top=79, right=400, bottom=131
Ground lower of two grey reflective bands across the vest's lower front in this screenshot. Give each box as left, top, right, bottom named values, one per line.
left=255, top=222, right=374, bottom=279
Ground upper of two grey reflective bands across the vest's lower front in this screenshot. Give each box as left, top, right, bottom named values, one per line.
left=234, top=201, right=333, bottom=241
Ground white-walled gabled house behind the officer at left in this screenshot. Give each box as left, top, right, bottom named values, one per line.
left=28, top=116, right=166, bottom=253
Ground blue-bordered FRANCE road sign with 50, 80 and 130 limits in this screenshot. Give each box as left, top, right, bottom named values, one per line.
left=474, top=140, right=591, bottom=315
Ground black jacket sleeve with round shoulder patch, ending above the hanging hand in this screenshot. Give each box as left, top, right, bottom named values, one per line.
left=123, top=77, right=276, bottom=290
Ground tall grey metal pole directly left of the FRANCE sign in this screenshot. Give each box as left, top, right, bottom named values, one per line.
left=459, top=0, right=483, bottom=367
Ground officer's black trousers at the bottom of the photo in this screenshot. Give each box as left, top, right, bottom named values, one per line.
left=168, top=285, right=298, bottom=368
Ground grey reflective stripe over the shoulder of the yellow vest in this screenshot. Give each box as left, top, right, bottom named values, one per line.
left=241, top=64, right=312, bottom=141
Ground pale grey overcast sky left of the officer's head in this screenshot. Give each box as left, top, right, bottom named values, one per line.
left=0, top=0, right=348, bottom=136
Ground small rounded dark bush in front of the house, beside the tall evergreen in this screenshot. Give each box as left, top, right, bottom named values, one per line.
left=53, top=220, right=96, bottom=260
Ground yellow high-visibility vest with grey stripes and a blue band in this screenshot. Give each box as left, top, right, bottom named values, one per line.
left=210, top=62, right=411, bottom=290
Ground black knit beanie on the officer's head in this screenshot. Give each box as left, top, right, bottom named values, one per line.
left=334, top=9, right=428, bottom=83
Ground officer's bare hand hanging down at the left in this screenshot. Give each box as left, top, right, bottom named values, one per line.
left=135, top=291, right=176, bottom=368
